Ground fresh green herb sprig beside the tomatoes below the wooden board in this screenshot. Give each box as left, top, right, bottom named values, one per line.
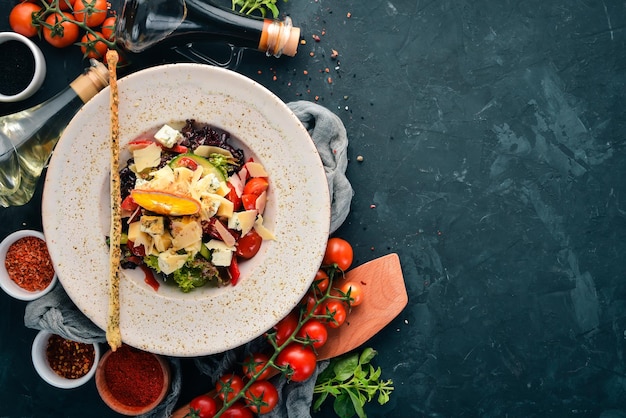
left=313, top=348, right=393, bottom=418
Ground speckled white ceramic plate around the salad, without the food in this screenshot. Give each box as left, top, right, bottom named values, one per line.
left=42, top=64, right=330, bottom=356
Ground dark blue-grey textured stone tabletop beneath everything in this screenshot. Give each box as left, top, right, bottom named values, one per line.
left=0, top=0, right=626, bottom=418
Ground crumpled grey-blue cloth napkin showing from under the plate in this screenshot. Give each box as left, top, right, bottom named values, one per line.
left=24, top=101, right=353, bottom=418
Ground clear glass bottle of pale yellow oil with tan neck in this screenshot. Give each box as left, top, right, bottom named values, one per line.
left=0, top=60, right=109, bottom=207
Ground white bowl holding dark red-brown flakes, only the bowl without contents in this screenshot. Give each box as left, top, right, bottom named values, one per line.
left=31, top=331, right=100, bottom=389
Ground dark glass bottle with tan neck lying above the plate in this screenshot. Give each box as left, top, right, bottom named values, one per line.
left=116, top=0, right=300, bottom=57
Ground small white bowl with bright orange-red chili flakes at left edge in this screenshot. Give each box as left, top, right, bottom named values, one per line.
left=0, top=229, right=57, bottom=301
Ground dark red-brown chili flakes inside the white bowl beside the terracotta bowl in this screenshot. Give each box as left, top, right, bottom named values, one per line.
left=46, top=335, right=96, bottom=379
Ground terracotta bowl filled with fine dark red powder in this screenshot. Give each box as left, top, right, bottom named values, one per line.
left=96, top=344, right=171, bottom=416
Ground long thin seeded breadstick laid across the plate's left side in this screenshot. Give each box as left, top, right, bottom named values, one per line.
left=106, top=50, right=122, bottom=351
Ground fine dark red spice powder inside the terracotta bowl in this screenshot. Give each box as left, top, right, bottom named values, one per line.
left=104, top=345, right=164, bottom=406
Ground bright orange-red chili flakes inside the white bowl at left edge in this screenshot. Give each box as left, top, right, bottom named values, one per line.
left=4, top=237, right=54, bottom=292
